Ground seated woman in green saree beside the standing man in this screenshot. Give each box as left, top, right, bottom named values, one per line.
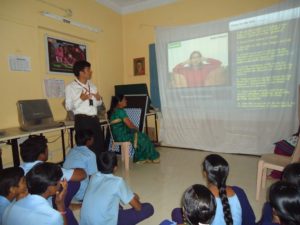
left=107, top=95, right=160, bottom=163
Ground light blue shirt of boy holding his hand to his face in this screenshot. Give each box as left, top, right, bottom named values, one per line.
left=2, top=195, right=64, bottom=225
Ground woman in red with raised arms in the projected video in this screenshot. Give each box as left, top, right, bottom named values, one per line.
left=173, top=51, right=221, bottom=87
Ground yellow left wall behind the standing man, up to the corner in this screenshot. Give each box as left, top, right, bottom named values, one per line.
left=0, top=0, right=123, bottom=129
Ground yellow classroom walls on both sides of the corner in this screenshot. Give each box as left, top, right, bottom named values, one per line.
left=0, top=0, right=282, bottom=167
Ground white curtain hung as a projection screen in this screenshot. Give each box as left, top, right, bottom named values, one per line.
left=156, top=1, right=300, bottom=154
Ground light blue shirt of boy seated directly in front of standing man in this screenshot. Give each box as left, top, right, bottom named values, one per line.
left=63, top=146, right=98, bottom=200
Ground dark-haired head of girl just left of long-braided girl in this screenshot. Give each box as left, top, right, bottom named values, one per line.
left=160, top=184, right=216, bottom=225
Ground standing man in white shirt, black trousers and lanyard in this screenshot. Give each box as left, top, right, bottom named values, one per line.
left=65, top=61, right=105, bottom=156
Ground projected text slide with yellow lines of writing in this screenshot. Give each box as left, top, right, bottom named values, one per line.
left=230, top=8, right=299, bottom=108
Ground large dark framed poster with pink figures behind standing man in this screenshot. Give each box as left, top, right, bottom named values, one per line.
left=46, top=36, right=87, bottom=74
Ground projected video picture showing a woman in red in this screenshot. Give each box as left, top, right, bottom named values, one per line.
left=168, top=33, right=230, bottom=87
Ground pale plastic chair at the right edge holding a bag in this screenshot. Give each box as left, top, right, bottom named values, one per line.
left=256, top=134, right=300, bottom=200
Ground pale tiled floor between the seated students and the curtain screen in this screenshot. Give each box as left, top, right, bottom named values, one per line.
left=75, top=147, right=272, bottom=225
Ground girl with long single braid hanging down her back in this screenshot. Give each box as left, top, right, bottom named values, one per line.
left=203, top=154, right=242, bottom=225
